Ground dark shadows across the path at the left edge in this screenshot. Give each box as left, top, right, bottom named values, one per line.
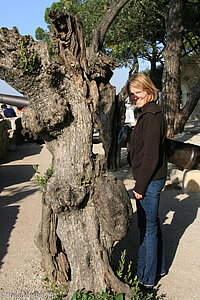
left=0, top=144, right=42, bottom=266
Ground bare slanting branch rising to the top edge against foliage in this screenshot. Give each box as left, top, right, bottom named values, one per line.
left=92, top=0, right=132, bottom=52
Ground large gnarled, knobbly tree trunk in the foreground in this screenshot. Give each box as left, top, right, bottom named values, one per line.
left=0, top=6, right=132, bottom=299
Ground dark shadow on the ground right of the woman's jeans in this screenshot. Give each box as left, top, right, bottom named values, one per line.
left=160, top=190, right=200, bottom=270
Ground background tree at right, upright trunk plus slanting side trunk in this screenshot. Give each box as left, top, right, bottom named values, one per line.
left=162, top=0, right=200, bottom=138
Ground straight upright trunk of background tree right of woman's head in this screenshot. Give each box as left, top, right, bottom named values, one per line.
left=162, top=0, right=183, bottom=138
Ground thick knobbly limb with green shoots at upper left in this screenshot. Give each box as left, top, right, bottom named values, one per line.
left=0, top=27, right=48, bottom=96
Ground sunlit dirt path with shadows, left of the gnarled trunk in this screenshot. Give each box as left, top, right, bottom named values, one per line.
left=0, top=144, right=51, bottom=300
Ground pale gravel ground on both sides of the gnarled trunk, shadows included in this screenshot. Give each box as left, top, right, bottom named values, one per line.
left=0, top=123, right=200, bottom=300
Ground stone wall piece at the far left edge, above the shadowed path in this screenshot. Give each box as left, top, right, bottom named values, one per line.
left=0, top=120, right=9, bottom=161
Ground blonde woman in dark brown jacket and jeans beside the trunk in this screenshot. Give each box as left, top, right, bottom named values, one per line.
left=127, top=73, right=167, bottom=288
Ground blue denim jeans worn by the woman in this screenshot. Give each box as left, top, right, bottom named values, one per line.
left=136, top=178, right=166, bottom=285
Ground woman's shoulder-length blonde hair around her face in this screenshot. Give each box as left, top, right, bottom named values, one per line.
left=127, top=73, right=158, bottom=102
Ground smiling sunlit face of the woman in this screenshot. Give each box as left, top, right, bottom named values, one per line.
left=129, top=85, right=151, bottom=108
